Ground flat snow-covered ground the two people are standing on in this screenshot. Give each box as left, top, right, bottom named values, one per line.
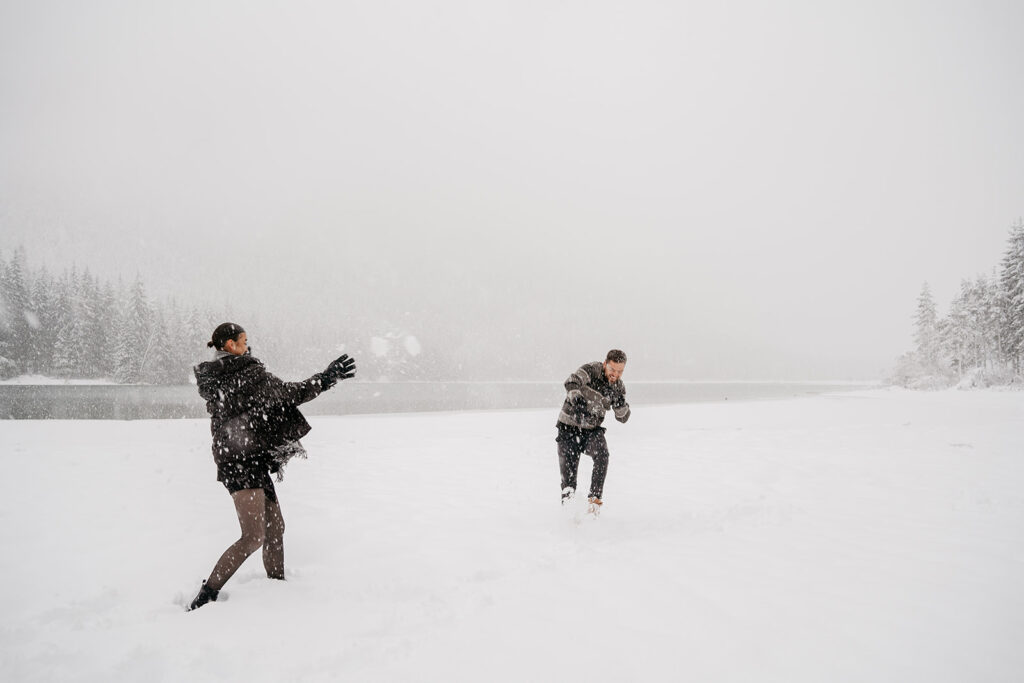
left=0, top=390, right=1024, bottom=683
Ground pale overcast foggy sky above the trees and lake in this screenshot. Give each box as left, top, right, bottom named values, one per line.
left=0, top=0, right=1024, bottom=379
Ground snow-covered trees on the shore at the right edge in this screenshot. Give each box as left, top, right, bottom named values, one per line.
left=892, top=220, right=1024, bottom=388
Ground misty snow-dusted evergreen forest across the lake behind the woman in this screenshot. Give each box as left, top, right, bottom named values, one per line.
left=0, top=247, right=440, bottom=384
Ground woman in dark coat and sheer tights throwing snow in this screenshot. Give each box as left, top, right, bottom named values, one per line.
left=188, top=323, right=355, bottom=610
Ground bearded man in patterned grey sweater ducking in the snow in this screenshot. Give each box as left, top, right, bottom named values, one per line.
left=555, top=349, right=630, bottom=517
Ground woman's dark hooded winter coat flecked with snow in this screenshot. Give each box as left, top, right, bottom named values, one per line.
left=194, top=355, right=324, bottom=471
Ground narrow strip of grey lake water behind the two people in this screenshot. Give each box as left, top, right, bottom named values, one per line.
left=0, top=381, right=864, bottom=420
